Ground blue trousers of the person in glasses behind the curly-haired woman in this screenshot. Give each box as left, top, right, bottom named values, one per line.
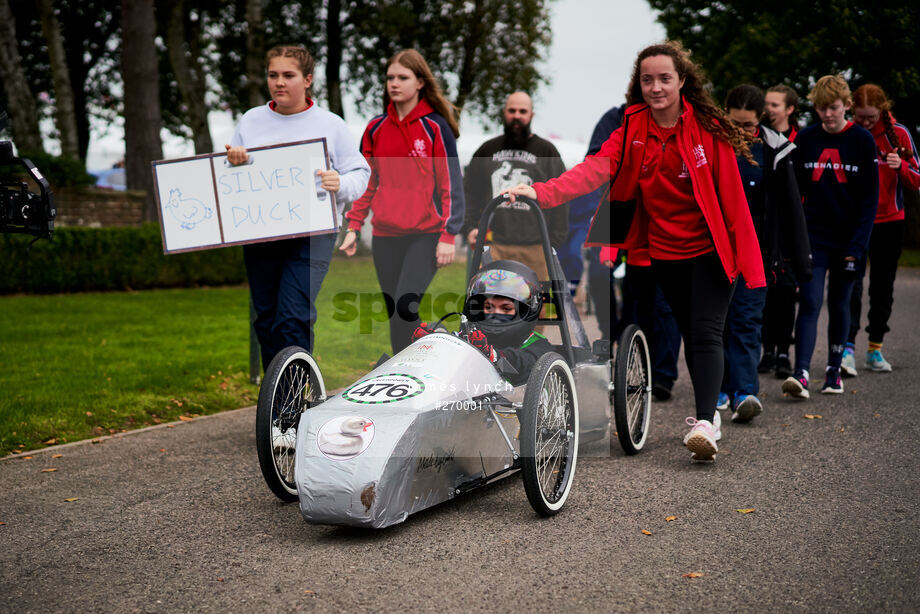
left=722, top=275, right=767, bottom=399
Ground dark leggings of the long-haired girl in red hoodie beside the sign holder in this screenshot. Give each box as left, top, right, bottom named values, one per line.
left=371, top=234, right=440, bottom=354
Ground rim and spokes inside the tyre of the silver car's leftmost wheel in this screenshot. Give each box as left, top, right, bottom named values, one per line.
left=271, top=361, right=317, bottom=492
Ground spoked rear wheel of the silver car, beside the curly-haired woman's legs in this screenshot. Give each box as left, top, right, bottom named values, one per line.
left=613, top=324, right=652, bottom=454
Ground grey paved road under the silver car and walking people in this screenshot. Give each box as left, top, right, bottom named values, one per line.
left=0, top=270, right=920, bottom=613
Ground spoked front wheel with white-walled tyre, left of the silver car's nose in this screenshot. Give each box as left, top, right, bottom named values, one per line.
left=256, top=346, right=326, bottom=501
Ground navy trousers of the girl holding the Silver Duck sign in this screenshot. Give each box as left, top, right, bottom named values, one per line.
left=243, top=234, right=335, bottom=369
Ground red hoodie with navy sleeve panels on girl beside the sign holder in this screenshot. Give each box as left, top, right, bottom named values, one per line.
left=345, top=99, right=464, bottom=244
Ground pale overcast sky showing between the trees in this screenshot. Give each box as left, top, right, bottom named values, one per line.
left=87, top=0, right=664, bottom=169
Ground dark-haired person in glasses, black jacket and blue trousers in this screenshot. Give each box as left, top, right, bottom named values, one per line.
left=718, top=84, right=811, bottom=422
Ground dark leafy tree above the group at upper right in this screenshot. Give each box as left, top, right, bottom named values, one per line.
left=649, top=0, right=920, bottom=131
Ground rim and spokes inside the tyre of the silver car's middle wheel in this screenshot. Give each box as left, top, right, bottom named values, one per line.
left=534, top=370, right=575, bottom=504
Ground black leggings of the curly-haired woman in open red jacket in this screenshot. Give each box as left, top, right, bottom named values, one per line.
left=652, top=251, right=733, bottom=422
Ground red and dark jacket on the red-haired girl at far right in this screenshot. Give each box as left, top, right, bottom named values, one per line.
left=871, top=116, right=920, bottom=224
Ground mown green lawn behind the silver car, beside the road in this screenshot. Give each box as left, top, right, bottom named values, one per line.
left=0, top=258, right=465, bottom=455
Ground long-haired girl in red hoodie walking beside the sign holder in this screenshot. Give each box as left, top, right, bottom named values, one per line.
left=339, top=49, right=464, bottom=354
